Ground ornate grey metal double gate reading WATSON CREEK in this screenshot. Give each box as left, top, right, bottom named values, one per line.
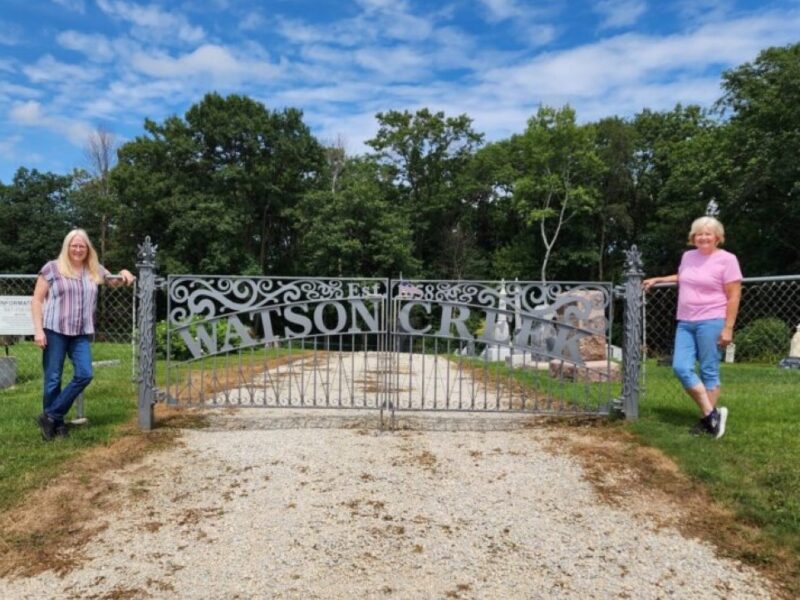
left=155, top=275, right=619, bottom=414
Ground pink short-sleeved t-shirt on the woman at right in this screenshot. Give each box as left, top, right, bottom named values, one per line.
left=678, top=250, right=742, bottom=321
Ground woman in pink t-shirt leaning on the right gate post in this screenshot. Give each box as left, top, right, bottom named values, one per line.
left=643, top=217, right=742, bottom=438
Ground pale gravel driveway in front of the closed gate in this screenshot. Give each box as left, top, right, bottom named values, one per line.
left=0, top=409, right=770, bottom=599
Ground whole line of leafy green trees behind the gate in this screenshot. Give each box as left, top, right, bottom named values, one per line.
left=0, top=44, right=800, bottom=281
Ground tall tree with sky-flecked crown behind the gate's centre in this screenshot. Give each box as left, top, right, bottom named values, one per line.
left=367, top=108, right=483, bottom=276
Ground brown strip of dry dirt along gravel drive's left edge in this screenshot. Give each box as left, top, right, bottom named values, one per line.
left=0, top=406, right=204, bottom=580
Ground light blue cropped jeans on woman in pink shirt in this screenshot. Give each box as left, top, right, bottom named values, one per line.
left=672, top=319, right=725, bottom=390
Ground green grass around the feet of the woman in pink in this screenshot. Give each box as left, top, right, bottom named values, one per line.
left=628, top=362, right=800, bottom=560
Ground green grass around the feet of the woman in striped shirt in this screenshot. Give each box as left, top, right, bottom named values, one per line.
left=0, top=344, right=136, bottom=510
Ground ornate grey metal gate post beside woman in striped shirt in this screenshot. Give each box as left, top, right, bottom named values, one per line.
left=136, top=236, right=158, bottom=431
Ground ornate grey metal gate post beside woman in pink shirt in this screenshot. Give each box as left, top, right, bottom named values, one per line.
left=622, top=245, right=644, bottom=419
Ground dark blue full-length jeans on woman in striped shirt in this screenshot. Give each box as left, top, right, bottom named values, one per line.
left=42, top=329, right=93, bottom=423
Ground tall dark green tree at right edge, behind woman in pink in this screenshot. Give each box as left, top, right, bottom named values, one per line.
left=717, top=44, right=800, bottom=274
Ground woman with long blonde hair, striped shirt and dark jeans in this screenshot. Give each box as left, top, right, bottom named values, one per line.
left=31, top=229, right=136, bottom=441
